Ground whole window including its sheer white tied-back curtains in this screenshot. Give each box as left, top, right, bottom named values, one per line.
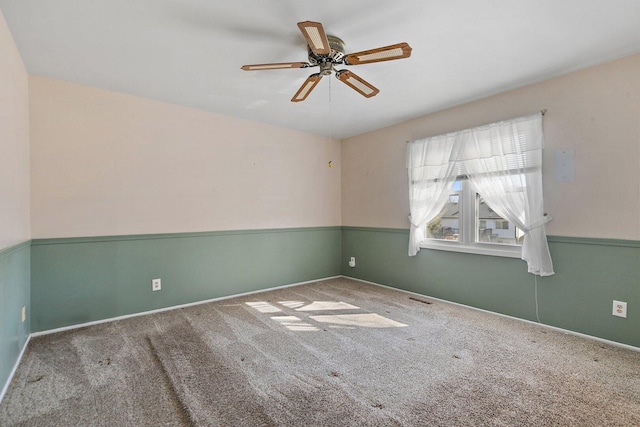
left=407, top=113, right=553, bottom=276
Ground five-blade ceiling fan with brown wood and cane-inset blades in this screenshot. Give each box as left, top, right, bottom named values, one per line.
left=242, top=21, right=411, bottom=102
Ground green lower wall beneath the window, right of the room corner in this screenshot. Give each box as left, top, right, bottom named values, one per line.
left=341, top=227, right=640, bottom=347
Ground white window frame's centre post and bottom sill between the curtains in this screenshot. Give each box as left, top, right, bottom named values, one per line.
left=420, top=177, right=522, bottom=258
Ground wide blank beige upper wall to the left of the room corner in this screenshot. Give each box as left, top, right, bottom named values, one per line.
left=29, top=75, right=341, bottom=238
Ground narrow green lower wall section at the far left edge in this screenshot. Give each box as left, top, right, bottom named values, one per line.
left=0, top=241, right=31, bottom=389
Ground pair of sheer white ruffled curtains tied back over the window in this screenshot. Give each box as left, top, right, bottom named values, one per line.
left=407, top=113, right=554, bottom=276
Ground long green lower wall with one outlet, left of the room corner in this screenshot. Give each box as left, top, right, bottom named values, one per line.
left=31, top=227, right=341, bottom=332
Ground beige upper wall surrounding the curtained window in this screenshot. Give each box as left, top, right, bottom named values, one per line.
left=342, top=55, right=640, bottom=240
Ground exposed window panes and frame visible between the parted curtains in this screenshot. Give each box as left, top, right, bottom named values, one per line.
left=421, top=179, right=524, bottom=257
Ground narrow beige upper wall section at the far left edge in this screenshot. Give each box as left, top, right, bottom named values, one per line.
left=0, top=12, right=30, bottom=250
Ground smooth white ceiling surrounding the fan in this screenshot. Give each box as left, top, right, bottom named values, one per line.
left=0, top=0, right=640, bottom=138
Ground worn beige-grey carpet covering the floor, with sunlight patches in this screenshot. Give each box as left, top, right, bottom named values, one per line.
left=0, top=279, right=640, bottom=426
